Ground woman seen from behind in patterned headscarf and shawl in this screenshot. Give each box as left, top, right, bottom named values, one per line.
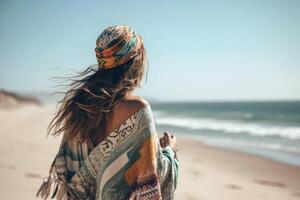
left=37, top=25, right=178, bottom=200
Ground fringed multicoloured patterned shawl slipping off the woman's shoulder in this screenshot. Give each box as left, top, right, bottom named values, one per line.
left=37, top=104, right=179, bottom=200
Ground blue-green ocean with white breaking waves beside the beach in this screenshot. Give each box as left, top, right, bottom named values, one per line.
left=151, top=101, right=300, bottom=166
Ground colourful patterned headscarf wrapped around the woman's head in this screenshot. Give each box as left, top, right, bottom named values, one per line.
left=95, top=25, right=143, bottom=69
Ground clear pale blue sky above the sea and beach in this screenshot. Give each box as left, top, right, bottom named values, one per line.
left=0, top=0, right=300, bottom=100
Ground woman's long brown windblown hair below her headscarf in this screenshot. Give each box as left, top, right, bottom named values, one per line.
left=47, top=47, right=148, bottom=142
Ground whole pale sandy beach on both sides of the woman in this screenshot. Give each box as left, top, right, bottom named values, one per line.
left=0, top=105, right=300, bottom=200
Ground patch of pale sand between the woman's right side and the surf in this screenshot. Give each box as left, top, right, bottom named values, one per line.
left=176, top=137, right=300, bottom=200
